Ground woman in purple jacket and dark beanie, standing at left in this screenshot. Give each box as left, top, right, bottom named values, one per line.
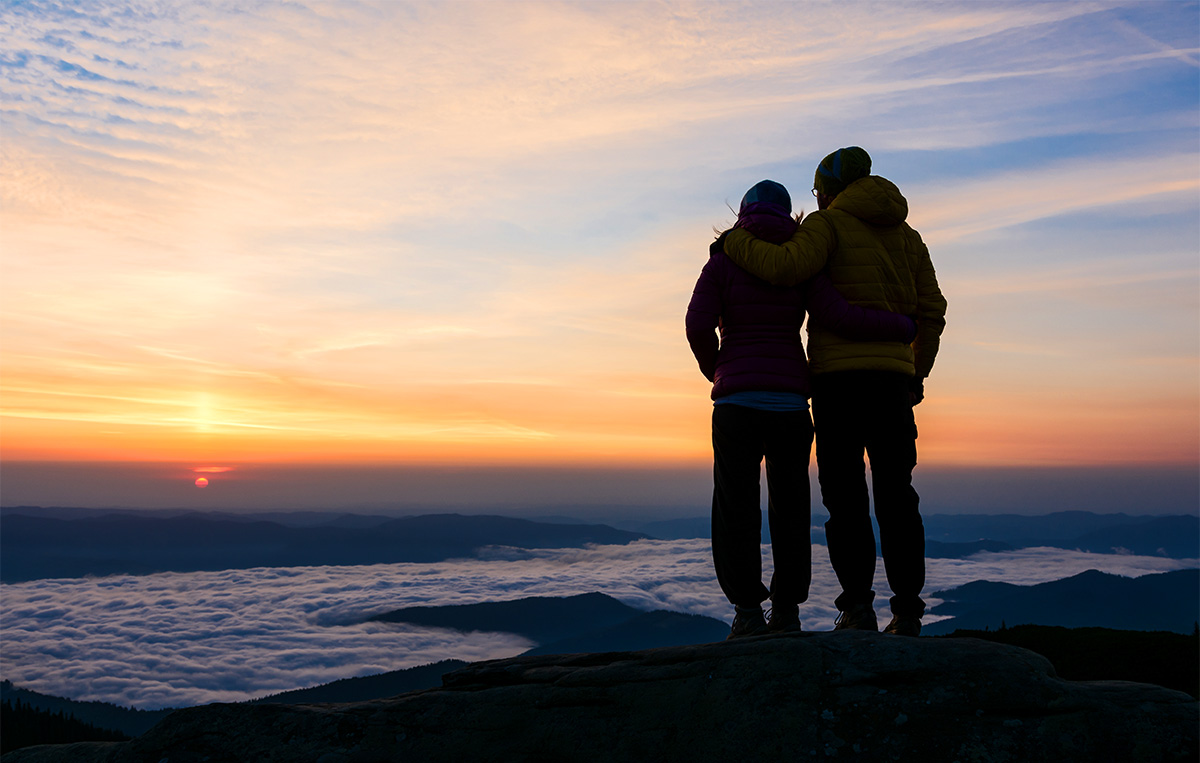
left=688, top=180, right=917, bottom=638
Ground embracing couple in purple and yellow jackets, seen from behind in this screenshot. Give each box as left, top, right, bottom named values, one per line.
left=686, top=146, right=946, bottom=638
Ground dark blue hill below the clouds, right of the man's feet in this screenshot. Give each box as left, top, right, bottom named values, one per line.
left=922, top=569, right=1200, bottom=636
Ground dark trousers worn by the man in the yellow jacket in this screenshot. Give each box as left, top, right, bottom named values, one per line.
left=812, top=371, right=925, bottom=617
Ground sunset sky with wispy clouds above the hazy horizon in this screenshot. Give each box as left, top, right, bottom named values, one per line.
left=0, top=0, right=1200, bottom=510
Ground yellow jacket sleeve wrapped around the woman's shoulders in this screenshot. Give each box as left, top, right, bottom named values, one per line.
left=725, top=212, right=836, bottom=286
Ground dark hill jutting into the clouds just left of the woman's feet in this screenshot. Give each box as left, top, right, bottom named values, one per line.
left=370, top=593, right=730, bottom=654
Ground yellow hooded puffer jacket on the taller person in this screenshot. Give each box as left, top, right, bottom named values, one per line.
left=725, top=175, right=946, bottom=379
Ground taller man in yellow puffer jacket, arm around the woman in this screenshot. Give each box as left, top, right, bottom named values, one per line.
left=725, top=146, right=946, bottom=636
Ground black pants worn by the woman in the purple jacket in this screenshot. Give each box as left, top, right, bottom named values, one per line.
left=713, top=404, right=812, bottom=607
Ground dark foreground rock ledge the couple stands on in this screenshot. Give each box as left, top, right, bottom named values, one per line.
left=4, top=632, right=1200, bottom=763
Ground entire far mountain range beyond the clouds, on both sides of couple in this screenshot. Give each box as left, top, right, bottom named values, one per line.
left=7, top=507, right=1200, bottom=582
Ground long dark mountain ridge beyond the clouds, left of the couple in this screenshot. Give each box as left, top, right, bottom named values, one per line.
left=0, top=512, right=644, bottom=582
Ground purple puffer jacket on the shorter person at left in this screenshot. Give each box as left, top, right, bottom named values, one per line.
left=686, top=214, right=916, bottom=399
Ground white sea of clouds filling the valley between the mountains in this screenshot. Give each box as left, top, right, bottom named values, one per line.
left=0, top=540, right=1196, bottom=709
